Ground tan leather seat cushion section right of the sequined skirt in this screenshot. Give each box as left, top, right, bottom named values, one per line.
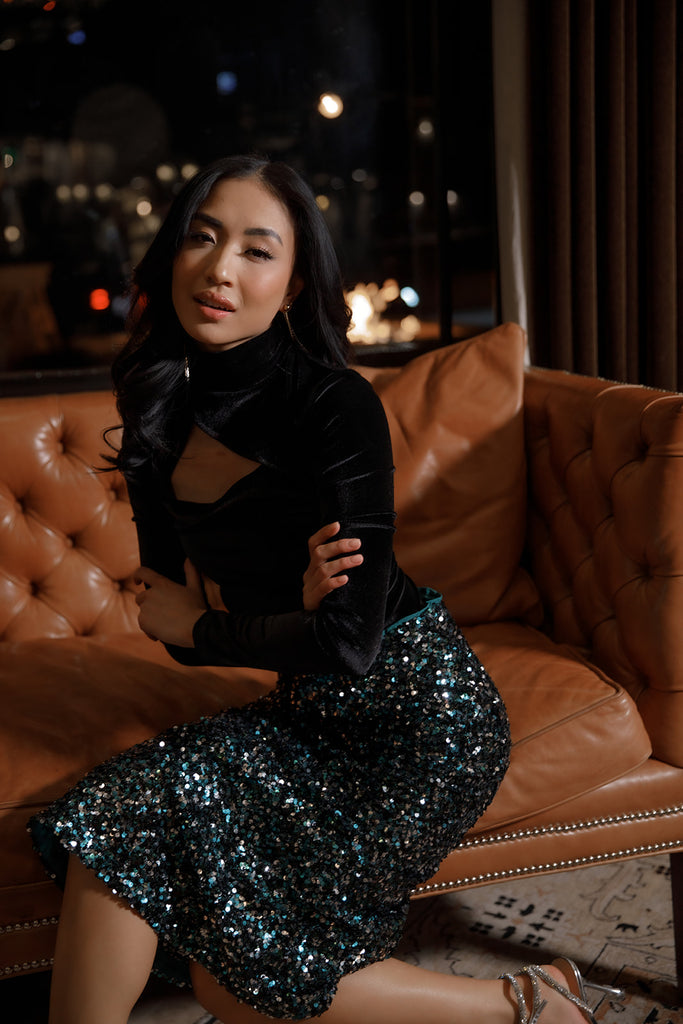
left=464, top=623, right=651, bottom=831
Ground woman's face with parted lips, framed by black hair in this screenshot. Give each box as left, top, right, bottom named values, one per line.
left=172, top=178, right=301, bottom=351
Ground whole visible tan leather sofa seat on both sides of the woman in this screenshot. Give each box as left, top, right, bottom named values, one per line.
left=0, top=623, right=650, bottom=884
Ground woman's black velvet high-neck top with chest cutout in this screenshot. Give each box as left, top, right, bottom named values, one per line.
left=128, top=328, right=422, bottom=674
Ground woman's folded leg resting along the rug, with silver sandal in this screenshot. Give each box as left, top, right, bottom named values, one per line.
left=190, top=958, right=586, bottom=1024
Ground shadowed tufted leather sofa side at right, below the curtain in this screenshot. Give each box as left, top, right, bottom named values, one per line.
left=524, top=369, right=683, bottom=767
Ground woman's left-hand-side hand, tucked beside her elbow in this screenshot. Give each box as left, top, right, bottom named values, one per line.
left=135, top=558, right=207, bottom=647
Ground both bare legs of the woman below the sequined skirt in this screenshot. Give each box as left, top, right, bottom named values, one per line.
left=50, top=857, right=585, bottom=1024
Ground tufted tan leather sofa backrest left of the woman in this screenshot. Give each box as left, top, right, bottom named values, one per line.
left=0, top=392, right=137, bottom=640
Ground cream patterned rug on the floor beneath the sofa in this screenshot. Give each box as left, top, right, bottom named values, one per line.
left=0, top=856, right=683, bottom=1024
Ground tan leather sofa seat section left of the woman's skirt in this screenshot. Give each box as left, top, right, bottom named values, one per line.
left=0, top=634, right=275, bottom=885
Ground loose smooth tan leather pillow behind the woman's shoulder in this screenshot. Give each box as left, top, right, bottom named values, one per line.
left=361, top=324, right=540, bottom=625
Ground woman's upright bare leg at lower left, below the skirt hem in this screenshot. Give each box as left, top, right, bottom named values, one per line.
left=50, top=857, right=157, bottom=1024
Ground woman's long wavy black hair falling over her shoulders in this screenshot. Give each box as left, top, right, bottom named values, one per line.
left=105, top=156, right=350, bottom=476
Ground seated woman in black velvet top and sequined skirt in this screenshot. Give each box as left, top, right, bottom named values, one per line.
left=26, top=158, right=618, bottom=1024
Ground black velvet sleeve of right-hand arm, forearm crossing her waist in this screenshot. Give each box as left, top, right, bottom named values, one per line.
left=189, top=373, right=401, bottom=674
